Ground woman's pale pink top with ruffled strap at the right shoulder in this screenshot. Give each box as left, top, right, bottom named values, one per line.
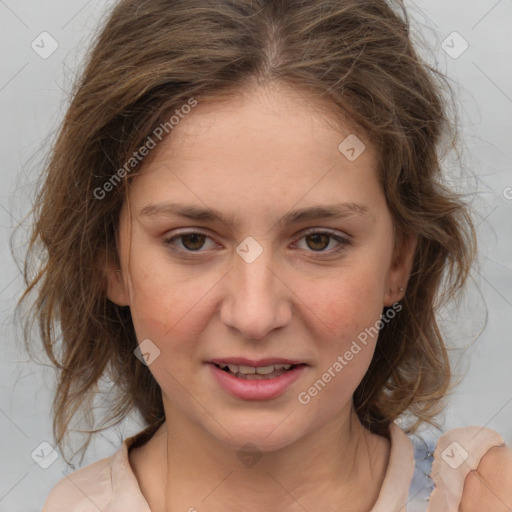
left=42, top=423, right=504, bottom=512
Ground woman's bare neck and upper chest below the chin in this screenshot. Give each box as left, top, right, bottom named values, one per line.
left=150, top=404, right=389, bottom=512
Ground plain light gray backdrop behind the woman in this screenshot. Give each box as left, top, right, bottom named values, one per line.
left=0, top=0, right=512, bottom=512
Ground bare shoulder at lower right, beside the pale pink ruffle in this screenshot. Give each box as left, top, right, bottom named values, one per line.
left=460, top=445, right=512, bottom=512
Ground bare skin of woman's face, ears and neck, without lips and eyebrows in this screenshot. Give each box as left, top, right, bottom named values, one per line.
left=108, top=84, right=416, bottom=512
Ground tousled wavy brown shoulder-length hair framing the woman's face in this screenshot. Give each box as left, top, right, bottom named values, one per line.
left=20, top=0, right=475, bottom=460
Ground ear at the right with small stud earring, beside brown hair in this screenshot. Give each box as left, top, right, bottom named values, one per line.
left=384, top=234, right=418, bottom=306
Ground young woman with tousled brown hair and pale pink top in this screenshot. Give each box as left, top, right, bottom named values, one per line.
left=25, top=0, right=512, bottom=512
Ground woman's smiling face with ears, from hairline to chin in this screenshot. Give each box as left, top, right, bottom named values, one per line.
left=109, top=85, right=412, bottom=451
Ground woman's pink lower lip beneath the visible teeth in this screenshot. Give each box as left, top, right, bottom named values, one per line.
left=208, top=363, right=306, bottom=400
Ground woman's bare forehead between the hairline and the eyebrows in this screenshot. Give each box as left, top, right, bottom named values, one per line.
left=129, top=81, right=378, bottom=216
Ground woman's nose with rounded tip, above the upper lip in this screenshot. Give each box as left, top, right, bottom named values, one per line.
left=220, top=243, right=293, bottom=340
